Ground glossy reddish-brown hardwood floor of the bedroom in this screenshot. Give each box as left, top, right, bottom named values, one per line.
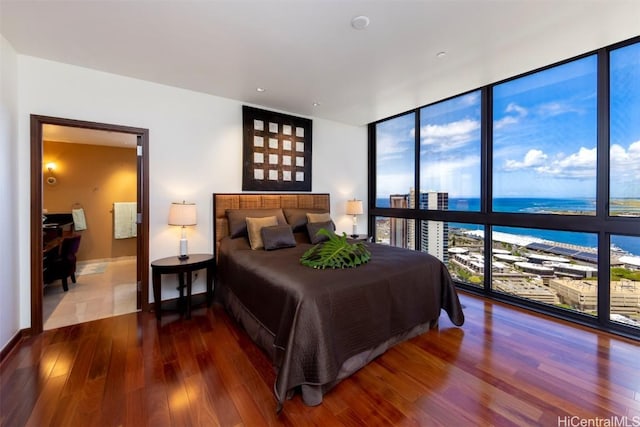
left=0, top=293, right=640, bottom=427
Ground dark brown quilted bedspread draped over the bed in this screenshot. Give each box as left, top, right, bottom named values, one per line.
left=216, top=238, right=464, bottom=403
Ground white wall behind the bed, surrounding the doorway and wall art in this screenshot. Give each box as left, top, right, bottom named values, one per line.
left=13, top=55, right=367, bottom=332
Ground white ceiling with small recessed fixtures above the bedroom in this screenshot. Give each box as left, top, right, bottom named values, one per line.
left=0, top=0, right=640, bottom=125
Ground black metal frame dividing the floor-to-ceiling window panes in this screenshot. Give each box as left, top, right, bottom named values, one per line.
left=368, top=37, right=640, bottom=340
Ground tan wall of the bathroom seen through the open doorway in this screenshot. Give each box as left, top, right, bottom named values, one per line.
left=42, top=141, right=137, bottom=260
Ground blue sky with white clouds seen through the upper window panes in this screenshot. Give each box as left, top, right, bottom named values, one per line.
left=377, top=44, right=640, bottom=202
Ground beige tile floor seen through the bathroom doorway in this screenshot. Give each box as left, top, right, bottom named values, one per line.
left=43, top=257, right=136, bottom=330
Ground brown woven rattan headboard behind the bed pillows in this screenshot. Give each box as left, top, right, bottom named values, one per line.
left=213, top=193, right=330, bottom=256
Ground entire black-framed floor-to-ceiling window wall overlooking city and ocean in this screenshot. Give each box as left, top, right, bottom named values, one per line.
left=369, top=39, right=640, bottom=338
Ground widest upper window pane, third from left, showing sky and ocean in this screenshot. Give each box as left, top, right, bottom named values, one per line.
left=492, top=55, right=598, bottom=215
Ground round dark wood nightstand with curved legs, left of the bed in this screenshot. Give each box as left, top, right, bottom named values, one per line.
left=151, top=254, right=216, bottom=320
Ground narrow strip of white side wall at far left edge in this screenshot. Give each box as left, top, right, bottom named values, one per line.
left=0, top=35, right=19, bottom=349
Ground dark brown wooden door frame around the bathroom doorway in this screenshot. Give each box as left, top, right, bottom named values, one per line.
left=30, top=114, right=150, bottom=334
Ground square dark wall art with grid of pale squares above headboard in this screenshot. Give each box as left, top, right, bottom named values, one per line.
left=242, top=105, right=312, bottom=191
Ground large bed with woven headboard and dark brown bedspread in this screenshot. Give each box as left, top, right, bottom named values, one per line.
left=213, top=193, right=464, bottom=410
